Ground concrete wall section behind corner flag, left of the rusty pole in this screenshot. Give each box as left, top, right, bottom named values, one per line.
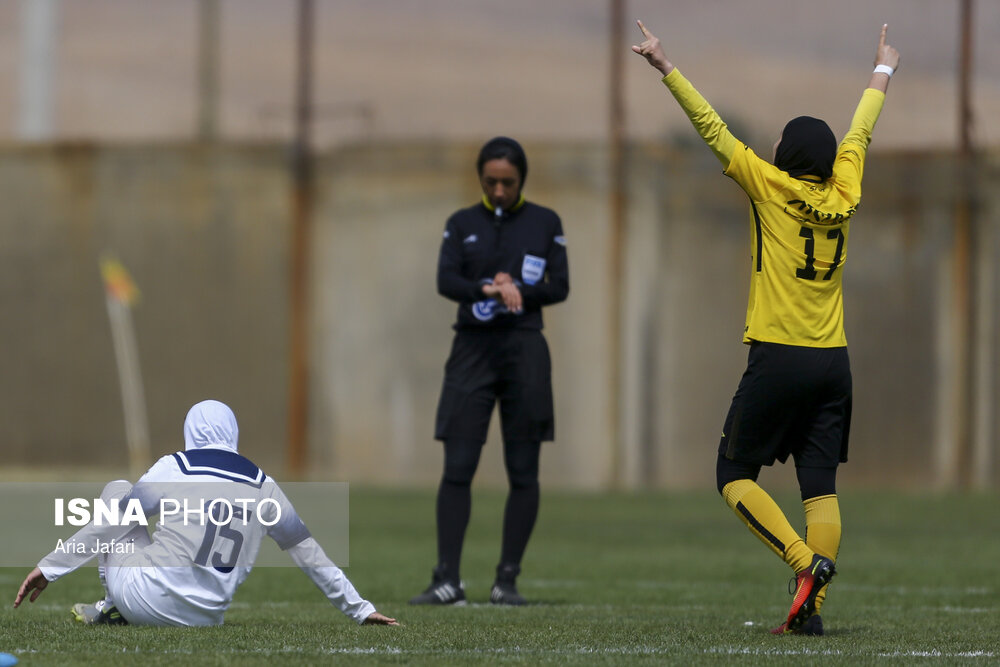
left=0, top=145, right=288, bottom=474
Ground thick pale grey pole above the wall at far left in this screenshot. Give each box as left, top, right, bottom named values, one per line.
left=17, top=0, right=58, bottom=141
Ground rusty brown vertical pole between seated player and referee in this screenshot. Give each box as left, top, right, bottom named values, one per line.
left=288, top=0, right=313, bottom=477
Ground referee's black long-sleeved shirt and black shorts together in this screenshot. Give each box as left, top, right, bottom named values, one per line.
left=434, top=201, right=569, bottom=444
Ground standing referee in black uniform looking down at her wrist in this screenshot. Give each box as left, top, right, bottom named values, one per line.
left=410, top=151, right=569, bottom=605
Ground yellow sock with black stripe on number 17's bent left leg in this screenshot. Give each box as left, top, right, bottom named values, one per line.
left=722, top=479, right=813, bottom=572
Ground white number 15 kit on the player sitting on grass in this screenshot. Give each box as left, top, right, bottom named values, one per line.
left=39, top=445, right=375, bottom=625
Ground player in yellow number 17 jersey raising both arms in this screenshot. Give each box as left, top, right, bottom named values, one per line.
left=632, top=21, right=899, bottom=635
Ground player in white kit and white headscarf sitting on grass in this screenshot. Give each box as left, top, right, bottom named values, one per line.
left=14, top=401, right=398, bottom=626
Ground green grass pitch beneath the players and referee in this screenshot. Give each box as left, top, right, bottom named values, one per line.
left=0, top=489, right=1000, bottom=667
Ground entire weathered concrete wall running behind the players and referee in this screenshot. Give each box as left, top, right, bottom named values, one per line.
left=0, top=143, right=1000, bottom=488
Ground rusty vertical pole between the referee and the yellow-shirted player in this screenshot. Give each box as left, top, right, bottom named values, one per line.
left=608, top=0, right=626, bottom=487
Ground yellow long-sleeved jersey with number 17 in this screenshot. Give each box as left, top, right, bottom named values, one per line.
left=663, top=68, right=885, bottom=347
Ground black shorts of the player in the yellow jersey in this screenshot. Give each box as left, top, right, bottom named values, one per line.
left=719, top=343, right=851, bottom=468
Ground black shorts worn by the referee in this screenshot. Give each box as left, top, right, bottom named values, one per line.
left=434, top=329, right=555, bottom=442
